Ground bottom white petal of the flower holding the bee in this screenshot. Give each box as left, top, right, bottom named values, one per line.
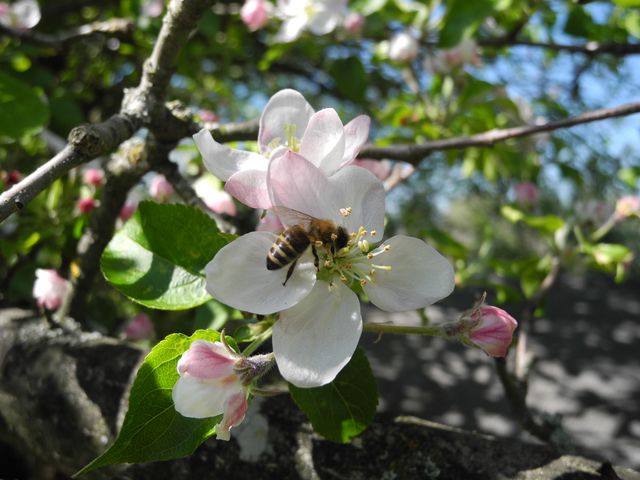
left=273, top=281, right=362, bottom=388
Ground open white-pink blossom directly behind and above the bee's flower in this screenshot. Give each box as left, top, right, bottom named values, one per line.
left=193, top=89, right=370, bottom=209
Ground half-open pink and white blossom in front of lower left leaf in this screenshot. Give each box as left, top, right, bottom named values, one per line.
left=172, top=338, right=272, bottom=440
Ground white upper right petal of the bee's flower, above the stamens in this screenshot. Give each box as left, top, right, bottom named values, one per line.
left=328, top=167, right=385, bottom=237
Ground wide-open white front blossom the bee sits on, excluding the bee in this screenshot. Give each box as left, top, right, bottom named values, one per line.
left=205, top=150, right=454, bottom=387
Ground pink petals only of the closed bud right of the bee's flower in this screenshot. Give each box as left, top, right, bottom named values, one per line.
left=466, top=305, right=518, bottom=357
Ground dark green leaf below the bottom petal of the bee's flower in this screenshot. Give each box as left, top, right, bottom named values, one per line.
left=289, top=348, right=378, bottom=443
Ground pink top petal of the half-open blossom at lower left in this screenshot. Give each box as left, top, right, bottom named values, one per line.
left=178, top=340, right=237, bottom=380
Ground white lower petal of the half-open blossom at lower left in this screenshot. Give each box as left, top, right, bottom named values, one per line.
left=172, top=375, right=242, bottom=418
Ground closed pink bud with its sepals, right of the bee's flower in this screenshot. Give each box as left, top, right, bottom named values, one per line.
left=449, top=299, right=518, bottom=357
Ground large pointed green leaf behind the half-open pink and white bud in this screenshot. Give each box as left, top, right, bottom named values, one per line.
left=74, top=330, right=232, bottom=476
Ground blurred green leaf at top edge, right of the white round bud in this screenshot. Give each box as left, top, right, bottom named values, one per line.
left=438, top=0, right=495, bottom=48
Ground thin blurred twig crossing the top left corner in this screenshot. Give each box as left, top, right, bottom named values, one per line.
left=0, top=18, right=133, bottom=50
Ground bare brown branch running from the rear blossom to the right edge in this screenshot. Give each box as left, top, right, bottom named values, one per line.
left=358, top=102, right=640, bottom=164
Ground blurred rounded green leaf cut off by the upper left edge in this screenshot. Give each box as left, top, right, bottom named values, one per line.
left=0, top=72, right=49, bottom=139
